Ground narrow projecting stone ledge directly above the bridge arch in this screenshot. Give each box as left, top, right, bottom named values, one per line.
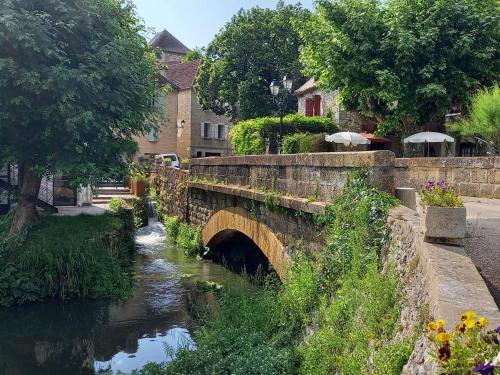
left=189, top=181, right=327, bottom=215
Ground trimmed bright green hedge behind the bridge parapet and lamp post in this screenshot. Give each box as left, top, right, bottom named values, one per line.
left=230, top=113, right=338, bottom=155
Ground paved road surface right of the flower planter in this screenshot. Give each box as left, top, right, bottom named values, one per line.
left=463, top=197, right=500, bottom=306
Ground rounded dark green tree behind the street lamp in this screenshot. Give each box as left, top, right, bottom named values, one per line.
left=195, top=1, right=309, bottom=119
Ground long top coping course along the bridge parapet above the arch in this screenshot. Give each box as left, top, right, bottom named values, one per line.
left=191, top=150, right=395, bottom=167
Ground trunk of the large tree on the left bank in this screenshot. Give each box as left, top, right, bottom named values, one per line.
left=9, top=166, right=42, bottom=236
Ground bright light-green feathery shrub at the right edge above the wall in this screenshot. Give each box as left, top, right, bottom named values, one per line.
left=452, top=84, right=500, bottom=147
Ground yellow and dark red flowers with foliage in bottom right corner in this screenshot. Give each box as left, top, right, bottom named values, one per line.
left=427, top=311, right=500, bottom=375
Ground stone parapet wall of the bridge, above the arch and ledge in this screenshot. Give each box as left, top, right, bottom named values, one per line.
left=191, top=151, right=394, bottom=201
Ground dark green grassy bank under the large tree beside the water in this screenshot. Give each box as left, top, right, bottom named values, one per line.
left=0, top=215, right=134, bottom=306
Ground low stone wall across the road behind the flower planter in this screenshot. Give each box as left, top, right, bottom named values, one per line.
left=394, top=156, right=500, bottom=199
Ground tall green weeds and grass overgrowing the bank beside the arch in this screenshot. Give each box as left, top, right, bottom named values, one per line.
left=134, top=171, right=415, bottom=375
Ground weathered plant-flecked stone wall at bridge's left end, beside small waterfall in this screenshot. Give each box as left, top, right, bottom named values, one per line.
left=150, top=166, right=189, bottom=221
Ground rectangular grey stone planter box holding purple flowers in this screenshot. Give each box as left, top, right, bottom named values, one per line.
left=423, top=206, right=466, bottom=246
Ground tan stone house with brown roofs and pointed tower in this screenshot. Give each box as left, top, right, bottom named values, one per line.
left=135, top=30, right=232, bottom=162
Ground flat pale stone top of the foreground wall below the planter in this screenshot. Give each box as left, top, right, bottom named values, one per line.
left=389, top=206, right=500, bottom=330
